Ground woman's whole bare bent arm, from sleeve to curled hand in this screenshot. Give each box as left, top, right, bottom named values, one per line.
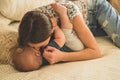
left=43, top=2, right=102, bottom=64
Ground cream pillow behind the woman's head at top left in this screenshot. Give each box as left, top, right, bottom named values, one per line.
left=0, top=0, right=54, bottom=20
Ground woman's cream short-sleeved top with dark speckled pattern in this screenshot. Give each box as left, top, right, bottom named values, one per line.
left=35, top=0, right=87, bottom=22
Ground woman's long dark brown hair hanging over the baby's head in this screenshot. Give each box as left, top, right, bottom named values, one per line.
left=18, top=11, right=52, bottom=46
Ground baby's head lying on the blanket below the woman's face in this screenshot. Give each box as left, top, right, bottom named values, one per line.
left=13, top=47, right=42, bottom=72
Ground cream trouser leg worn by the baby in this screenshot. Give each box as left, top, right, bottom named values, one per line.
left=62, top=28, right=84, bottom=51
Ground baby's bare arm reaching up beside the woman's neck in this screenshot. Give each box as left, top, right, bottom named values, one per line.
left=51, top=18, right=66, bottom=47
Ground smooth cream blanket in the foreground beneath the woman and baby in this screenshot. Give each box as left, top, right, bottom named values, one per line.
left=0, top=37, right=120, bottom=80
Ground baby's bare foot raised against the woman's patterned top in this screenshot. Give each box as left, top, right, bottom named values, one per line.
left=51, top=3, right=67, bottom=15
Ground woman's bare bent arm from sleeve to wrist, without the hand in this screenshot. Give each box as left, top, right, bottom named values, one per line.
left=63, top=15, right=102, bottom=61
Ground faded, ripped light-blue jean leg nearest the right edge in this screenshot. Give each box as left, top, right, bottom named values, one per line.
left=94, top=0, right=120, bottom=47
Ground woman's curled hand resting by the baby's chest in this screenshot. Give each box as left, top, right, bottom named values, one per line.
left=43, top=46, right=63, bottom=64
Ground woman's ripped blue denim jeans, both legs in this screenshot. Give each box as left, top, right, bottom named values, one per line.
left=88, top=0, right=120, bottom=47
